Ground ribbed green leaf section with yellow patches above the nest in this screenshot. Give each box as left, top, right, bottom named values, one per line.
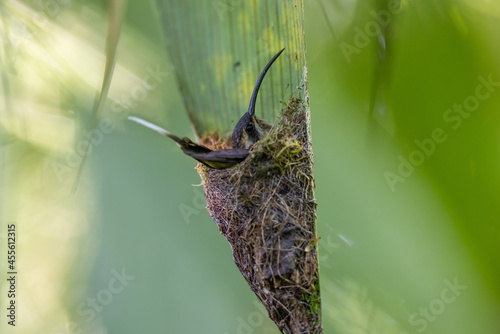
left=157, top=0, right=305, bottom=136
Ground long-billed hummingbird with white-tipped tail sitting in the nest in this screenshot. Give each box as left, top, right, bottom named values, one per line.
left=128, top=48, right=285, bottom=169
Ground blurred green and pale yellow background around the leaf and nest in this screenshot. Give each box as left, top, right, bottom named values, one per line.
left=0, top=0, right=500, bottom=334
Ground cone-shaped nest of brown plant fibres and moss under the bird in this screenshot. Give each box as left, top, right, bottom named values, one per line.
left=197, top=99, right=322, bottom=333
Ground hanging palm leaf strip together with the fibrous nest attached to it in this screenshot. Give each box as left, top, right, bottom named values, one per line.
left=154, top=0, right=322, bottom=333
